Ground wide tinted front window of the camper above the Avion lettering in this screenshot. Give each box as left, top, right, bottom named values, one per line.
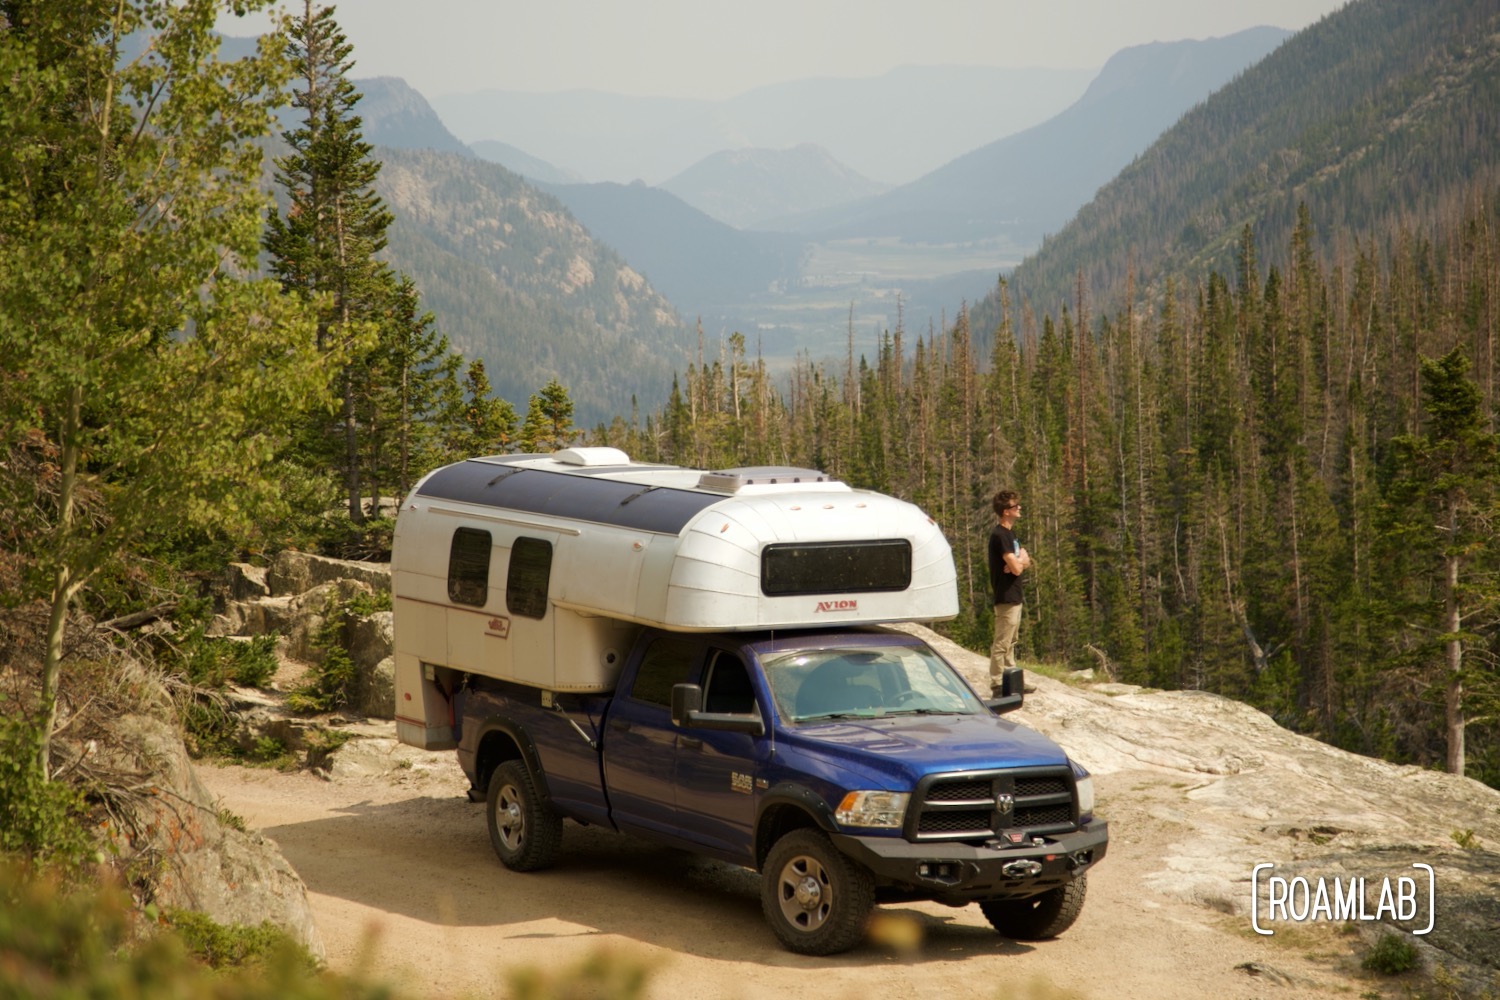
left=761, top=538, right=912, bottom=597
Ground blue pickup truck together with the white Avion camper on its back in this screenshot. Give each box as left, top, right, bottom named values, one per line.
left=393, top=448, right=1109, bottom=955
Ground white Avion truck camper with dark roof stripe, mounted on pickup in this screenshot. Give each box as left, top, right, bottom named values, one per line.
left=392, top=448, right=959, bottom=750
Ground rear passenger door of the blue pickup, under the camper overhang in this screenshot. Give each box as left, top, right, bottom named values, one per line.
left=605, top=636, right=704, bottom=838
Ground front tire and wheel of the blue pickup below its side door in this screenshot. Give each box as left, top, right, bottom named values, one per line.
left=761, top=828, right=875, bottom=955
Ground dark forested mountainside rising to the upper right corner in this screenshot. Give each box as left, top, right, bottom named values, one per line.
left=975, top=0, right=1500, bottom=330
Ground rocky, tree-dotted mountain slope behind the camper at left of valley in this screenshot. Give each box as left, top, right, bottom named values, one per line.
left=377, top=147, right=689, bottom=426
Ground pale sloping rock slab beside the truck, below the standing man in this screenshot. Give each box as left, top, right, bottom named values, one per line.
left=914, top=628, right=1500, bottom=990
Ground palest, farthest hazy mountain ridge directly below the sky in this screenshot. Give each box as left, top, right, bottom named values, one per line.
left=431, top=66, right=1095, bottom=184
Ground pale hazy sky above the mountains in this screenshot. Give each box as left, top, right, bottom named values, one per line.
left=219, top=0, right=1362, bottom=100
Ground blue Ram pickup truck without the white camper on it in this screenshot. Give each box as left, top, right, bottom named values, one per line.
left=458, top=628, right=1109, bottom=955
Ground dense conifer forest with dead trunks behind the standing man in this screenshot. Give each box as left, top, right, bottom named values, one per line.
left=596, top=206, right=1500, bottom=784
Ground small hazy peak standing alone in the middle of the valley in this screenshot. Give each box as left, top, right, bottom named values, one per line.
left=659, top=142, right=890, bottom=229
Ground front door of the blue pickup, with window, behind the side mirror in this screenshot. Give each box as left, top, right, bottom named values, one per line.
left=677, top=649, right=765, bottom=858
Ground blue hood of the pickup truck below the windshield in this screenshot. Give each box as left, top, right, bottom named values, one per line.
left=783, top=715, right=1068, bottom=783
